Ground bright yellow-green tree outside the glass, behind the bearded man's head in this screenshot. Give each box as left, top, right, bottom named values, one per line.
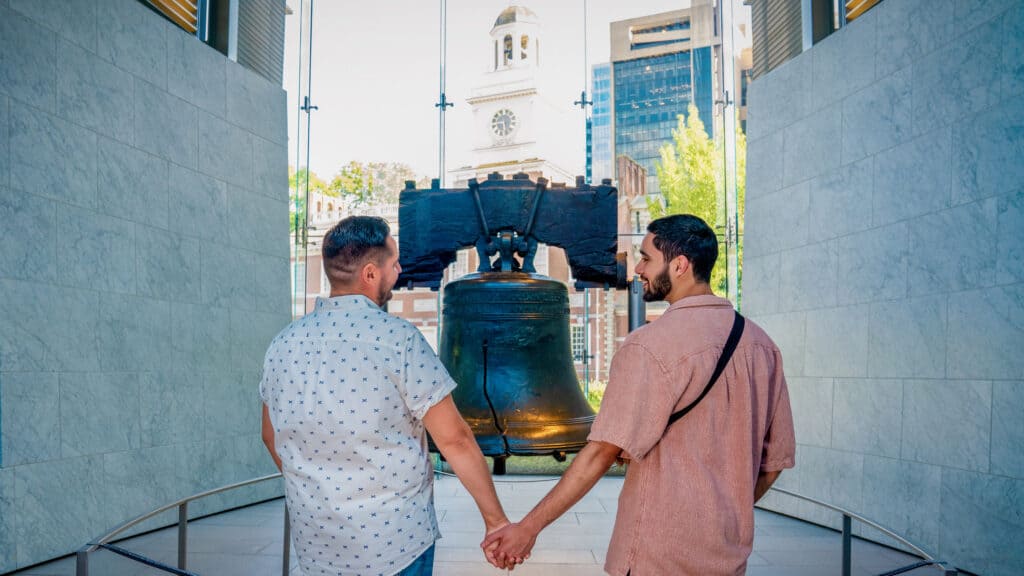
left=647, top=104, right=746, bottom=294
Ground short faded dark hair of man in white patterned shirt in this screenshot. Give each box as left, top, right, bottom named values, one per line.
left=322, top=216, right=391, bottom=285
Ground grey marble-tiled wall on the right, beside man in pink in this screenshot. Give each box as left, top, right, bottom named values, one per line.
left=743, top=0, right=1024, bottom=575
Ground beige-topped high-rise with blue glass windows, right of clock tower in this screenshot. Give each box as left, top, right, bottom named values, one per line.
left=610, top=0, right=721, bottom=194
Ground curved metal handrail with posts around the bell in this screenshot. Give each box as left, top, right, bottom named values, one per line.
left=75, top=470, right=957, bottom=576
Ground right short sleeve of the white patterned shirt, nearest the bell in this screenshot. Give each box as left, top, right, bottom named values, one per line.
left=401, top=328, right=456, bottom=420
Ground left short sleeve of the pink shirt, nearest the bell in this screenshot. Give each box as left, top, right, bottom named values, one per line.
left=588, top=342, right=684, bottom=460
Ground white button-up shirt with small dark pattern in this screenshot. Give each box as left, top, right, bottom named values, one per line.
left=260, top=296, right=456, bottom=576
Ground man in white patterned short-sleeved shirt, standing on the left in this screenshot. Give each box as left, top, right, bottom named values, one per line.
left=260, top=216, right=508, bottom=576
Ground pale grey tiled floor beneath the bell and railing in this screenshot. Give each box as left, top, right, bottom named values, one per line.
left=14, top=477, right=938, bottom=576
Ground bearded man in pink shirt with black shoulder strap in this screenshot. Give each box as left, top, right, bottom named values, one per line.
left=481, top=214, right=796, bottom=576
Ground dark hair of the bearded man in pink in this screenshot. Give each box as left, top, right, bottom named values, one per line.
left=647, top=214, right=718, bottom=283
